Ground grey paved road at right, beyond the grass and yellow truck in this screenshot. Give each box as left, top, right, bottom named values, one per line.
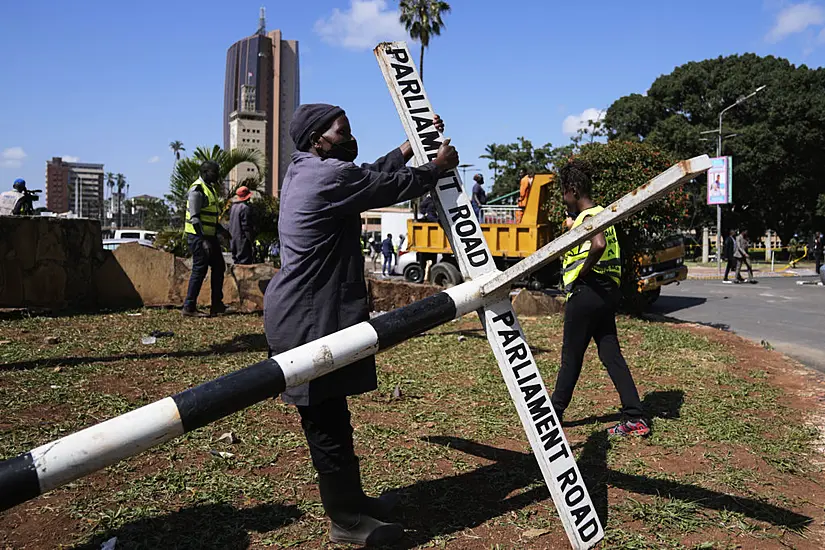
left=652, top=277, right=825, bottom=372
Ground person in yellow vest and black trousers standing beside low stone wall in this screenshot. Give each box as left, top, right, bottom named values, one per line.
left=181, top=160, right=228, bottom=317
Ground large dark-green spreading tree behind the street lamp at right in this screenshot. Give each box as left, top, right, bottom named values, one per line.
left=605, top=54, right=825, bottom=242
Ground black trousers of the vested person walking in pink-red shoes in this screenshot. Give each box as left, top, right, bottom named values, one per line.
left=550, top=284, right=644, bottom=419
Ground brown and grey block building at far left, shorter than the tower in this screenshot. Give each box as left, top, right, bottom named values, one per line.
left=44, top=157, right=104, bottom=220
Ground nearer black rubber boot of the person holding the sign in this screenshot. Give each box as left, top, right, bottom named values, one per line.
left=318, top=467, right=404, bottom=546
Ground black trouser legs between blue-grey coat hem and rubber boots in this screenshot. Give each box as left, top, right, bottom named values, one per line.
left=297, top=396, right=358, bottom=475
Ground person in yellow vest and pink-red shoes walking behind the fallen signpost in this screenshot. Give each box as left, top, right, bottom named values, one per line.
left=551, top=159, right=650, bottom=436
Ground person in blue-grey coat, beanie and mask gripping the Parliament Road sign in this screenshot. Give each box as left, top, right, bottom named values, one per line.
left=264, top=104, right=458, bottom=546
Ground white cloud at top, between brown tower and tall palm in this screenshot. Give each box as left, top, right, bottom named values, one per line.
left=315, top=0, right=407, bottom=50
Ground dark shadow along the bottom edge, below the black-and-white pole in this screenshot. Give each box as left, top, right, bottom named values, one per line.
left=73, top=504, right=301, bottom=550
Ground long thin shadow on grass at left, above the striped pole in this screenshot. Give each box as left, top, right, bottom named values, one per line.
left=0, top=333, right=269, bottom=371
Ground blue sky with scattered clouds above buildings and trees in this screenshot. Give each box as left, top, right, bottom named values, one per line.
left=0, top=0, right=825, bottom=207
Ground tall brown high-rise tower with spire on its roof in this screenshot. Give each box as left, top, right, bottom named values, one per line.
left=223, top=8, right=300, bottom=196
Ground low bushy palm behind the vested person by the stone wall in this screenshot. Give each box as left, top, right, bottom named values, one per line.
left=166, top=145, right=266, bottom=222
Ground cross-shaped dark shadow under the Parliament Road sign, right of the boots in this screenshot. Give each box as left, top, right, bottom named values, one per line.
left=384, top=391, right=813, bottom=549
